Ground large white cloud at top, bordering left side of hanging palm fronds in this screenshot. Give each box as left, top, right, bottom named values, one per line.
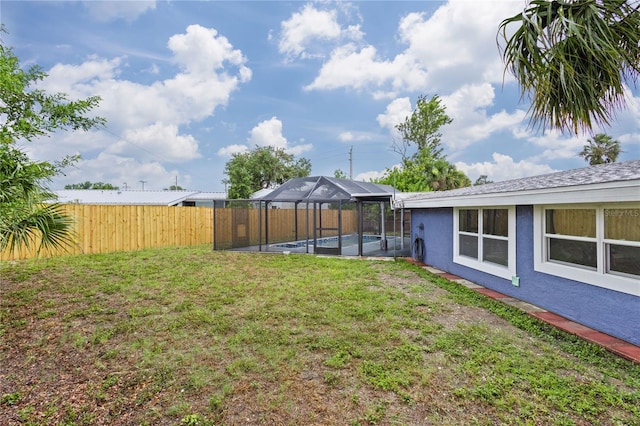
left=306, top=1, right=522, bottom=98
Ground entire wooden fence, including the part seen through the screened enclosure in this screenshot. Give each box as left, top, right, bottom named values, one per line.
left=0, top=204, right=364, bottom=261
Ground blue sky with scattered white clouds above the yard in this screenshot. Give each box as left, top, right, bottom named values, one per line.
left=0, top=0, right=640, bottom=191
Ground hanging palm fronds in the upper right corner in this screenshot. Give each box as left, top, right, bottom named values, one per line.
left=499, top=0, right=640, bottom=133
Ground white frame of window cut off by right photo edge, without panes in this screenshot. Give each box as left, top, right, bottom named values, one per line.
left=533, top=203, right=640, bottom=296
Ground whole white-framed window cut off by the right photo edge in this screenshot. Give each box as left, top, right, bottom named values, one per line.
left=534, top=204, right=640, bottom=295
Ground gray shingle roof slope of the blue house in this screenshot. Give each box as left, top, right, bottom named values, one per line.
left=406, top=160, right=640, bottom=201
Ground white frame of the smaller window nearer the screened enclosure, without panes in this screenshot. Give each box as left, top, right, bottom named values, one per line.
left=453, top=206, right=516, bottom=280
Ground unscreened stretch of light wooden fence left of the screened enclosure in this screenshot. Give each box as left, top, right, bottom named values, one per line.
left=0, top=204, right=213, bottom=260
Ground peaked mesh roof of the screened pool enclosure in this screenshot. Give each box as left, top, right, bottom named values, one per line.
left=259, top=176, right=394, bottom=202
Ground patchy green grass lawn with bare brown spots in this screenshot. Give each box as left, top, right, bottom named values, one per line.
left=0, top=247, right=640, bottom=425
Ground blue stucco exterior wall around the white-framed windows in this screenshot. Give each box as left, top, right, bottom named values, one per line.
left=411, top=206, right=640, bottom=346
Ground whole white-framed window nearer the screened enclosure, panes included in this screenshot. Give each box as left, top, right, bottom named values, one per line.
left=454, top=207, right=515, bottom=279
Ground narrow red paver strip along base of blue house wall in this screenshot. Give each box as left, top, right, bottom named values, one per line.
left=416, top=259, right=640, bottom=364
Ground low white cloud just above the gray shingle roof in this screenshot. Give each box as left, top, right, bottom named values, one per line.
left=455, top=152, right=556, bottom=182
